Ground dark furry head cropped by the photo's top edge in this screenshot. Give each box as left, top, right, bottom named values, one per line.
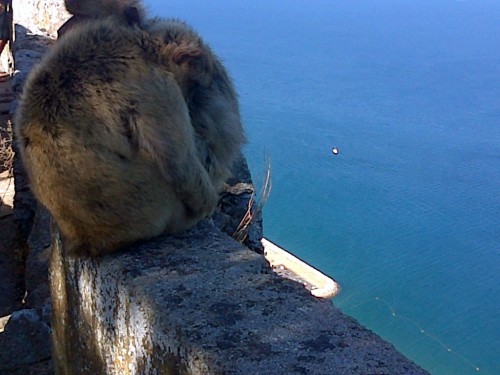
left=64, top=0, right=145, bottom=25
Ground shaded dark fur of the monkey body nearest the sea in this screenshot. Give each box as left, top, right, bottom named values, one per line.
left=145, top=20, right=244, bottom=185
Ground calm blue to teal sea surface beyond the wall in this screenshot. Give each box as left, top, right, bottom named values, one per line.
left=147, top=0, right=500, bottom=375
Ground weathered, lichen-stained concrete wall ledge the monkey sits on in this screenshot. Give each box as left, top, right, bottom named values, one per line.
left=51, top=222, right=426, bottom=375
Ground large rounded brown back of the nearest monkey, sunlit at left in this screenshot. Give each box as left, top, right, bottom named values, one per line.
left=15, top=20, right=217, bottom=255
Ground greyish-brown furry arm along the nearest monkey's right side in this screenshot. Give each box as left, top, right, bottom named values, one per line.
left=128, top=71, right=218, bottom=217
